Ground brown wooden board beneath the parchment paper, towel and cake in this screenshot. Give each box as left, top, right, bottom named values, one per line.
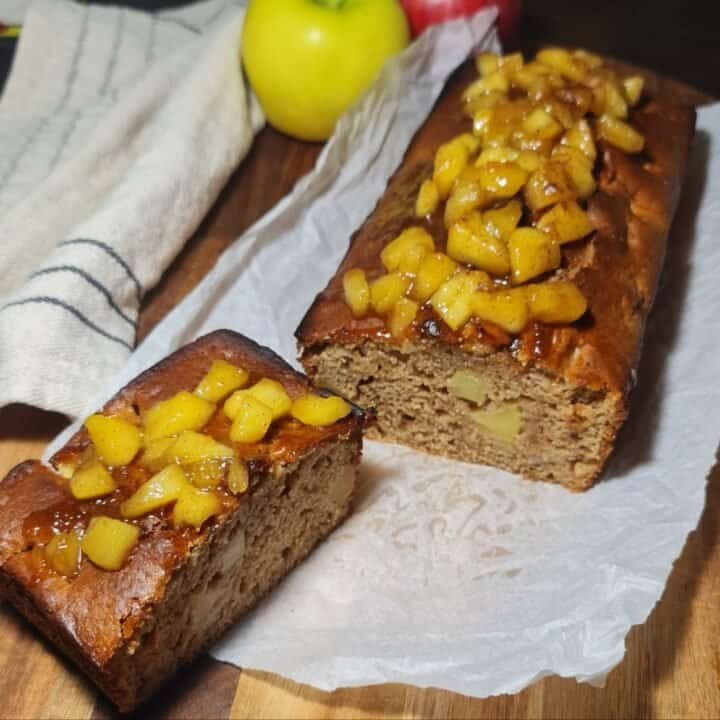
left=0, top=63, right=720, bottom=720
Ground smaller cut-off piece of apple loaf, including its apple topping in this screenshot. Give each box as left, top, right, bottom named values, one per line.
left=0, top=331, right=365, bottom=711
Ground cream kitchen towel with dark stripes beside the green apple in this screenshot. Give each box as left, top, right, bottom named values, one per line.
left=0, top=0, right=262, bottom=416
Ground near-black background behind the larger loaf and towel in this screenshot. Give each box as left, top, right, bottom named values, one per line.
left=0, top=0, right=720, bottom=97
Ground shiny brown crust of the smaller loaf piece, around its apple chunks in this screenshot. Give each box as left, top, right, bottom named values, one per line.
left=0, top=331, right=364, bottom=702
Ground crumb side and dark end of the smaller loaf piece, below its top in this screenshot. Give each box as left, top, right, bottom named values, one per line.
left=0, top=434, right=361, bottom=712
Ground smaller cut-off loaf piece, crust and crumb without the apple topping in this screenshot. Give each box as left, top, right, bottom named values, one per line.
left=0, top=332, right=364, bottom=711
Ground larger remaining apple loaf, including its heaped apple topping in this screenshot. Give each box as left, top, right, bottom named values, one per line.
left=297, top=48, right=695, bottom=490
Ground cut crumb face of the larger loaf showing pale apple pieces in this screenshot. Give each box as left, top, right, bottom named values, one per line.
left=302, top=341, right=625, bottom=491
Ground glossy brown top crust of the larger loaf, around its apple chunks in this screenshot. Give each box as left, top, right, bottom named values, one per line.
left=296, top=60, right=694, bottom=400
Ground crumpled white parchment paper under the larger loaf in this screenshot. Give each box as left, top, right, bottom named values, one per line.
left=46, top=15, right=720, bottom=696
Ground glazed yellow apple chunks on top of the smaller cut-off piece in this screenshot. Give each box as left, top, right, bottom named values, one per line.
left=33, top=359, right=351, bottom=578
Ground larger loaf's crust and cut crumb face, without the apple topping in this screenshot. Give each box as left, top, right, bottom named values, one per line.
left=297, top=52, right=694, bottom=490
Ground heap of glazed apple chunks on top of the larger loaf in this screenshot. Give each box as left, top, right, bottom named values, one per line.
left=343, top=48, right=644, bottom=340
